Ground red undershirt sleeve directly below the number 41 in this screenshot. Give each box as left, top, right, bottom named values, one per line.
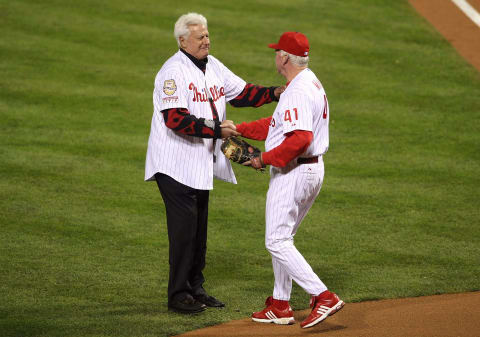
left=260, top=126, right=313, bottom=167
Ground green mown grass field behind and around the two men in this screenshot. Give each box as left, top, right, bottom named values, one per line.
left=0, top=0, right=480, bottom=337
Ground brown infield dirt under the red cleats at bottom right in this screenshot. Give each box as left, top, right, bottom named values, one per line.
left=177, top=292, right=480, bottom=337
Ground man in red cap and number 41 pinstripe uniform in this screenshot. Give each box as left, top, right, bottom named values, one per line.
left=236, top=32, right=344, bottom=328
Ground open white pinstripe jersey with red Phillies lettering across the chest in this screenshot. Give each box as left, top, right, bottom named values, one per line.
left=145, top=51, right=246, bottom=190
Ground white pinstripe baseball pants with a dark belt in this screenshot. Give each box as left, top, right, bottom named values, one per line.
left=265, top=157, right=327, bottom=301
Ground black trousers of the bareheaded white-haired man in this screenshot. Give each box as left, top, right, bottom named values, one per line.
left=155, top=173, right=209, bottom=303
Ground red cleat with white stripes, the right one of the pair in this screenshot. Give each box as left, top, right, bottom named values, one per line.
left=300, top=290, right=345, bottom=328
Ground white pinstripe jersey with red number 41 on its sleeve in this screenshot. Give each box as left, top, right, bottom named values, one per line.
left=265, top=68, right=330, bottom=157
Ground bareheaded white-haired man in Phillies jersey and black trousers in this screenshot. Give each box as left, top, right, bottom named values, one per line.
left=145, top=13, right=283, bottom=313
